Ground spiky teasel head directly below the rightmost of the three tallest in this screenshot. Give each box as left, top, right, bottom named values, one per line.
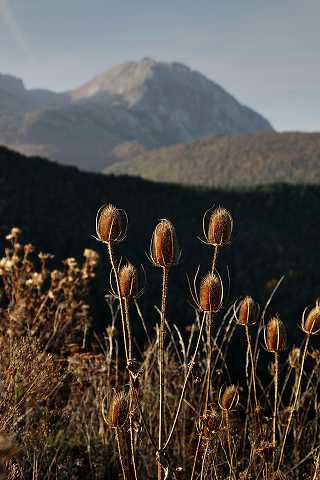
left=199, top=272, right=223, bottom=312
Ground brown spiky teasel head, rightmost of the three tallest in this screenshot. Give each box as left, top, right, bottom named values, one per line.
left=207, top=207, right=233, bottom=247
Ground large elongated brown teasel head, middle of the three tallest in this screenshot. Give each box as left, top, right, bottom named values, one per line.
left=151, top=219, right=179, bottom=267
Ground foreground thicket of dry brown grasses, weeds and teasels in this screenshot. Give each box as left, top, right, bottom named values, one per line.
left=0, top=206, right=320, bottom=480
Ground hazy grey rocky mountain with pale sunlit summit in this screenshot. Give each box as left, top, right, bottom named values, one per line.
left=0, top=58, right=272, bottom=171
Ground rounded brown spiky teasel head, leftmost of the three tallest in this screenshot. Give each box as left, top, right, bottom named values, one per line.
left=96, top=203, right=125, bottom=243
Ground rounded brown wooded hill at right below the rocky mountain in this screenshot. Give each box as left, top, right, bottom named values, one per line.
left=105, top=132, right=320, bottom=188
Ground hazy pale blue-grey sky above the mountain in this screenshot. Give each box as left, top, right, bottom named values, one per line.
left=0, top=0, right=320, bottom=131
